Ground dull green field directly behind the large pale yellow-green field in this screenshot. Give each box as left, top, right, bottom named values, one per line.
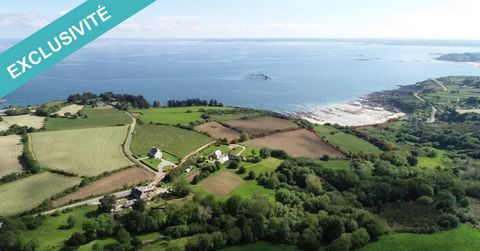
left=46, top=107, right=132, bottom=130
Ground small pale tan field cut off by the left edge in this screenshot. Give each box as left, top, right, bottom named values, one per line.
left=0, top=135, right=23, bottom=177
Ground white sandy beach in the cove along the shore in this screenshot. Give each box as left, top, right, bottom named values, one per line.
left=295, top=101, right=405, bottom=126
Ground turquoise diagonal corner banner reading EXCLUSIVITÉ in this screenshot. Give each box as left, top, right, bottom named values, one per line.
left=0, top=0, right=155, bottom=97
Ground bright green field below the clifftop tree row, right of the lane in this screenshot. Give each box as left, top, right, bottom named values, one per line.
left=131, top=106, right=231, bottom=125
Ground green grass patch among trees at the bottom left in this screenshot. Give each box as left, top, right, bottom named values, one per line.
left=25, top=206, right=96, bottom=250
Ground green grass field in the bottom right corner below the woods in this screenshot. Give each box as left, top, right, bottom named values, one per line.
left=362, top=225, right=480, bottom=251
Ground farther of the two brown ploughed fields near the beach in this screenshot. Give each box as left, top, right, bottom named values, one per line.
left=225, top=117, right=298, bottom=136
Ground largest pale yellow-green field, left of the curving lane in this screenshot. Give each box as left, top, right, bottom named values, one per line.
left=30, top=126, right=132, bottom=176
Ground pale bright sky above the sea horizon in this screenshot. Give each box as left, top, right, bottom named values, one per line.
left=0, top=0, right=480, bottom=40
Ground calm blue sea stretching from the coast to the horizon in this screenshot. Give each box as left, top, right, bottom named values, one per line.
left=0, top=39, right=480, bottom=112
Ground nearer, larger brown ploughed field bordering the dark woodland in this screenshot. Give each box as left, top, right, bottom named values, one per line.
left=243, top=129, right=345, bottom=158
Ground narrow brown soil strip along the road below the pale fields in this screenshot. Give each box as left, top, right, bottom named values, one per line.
left=52, top=167, right=155, bottom=207
